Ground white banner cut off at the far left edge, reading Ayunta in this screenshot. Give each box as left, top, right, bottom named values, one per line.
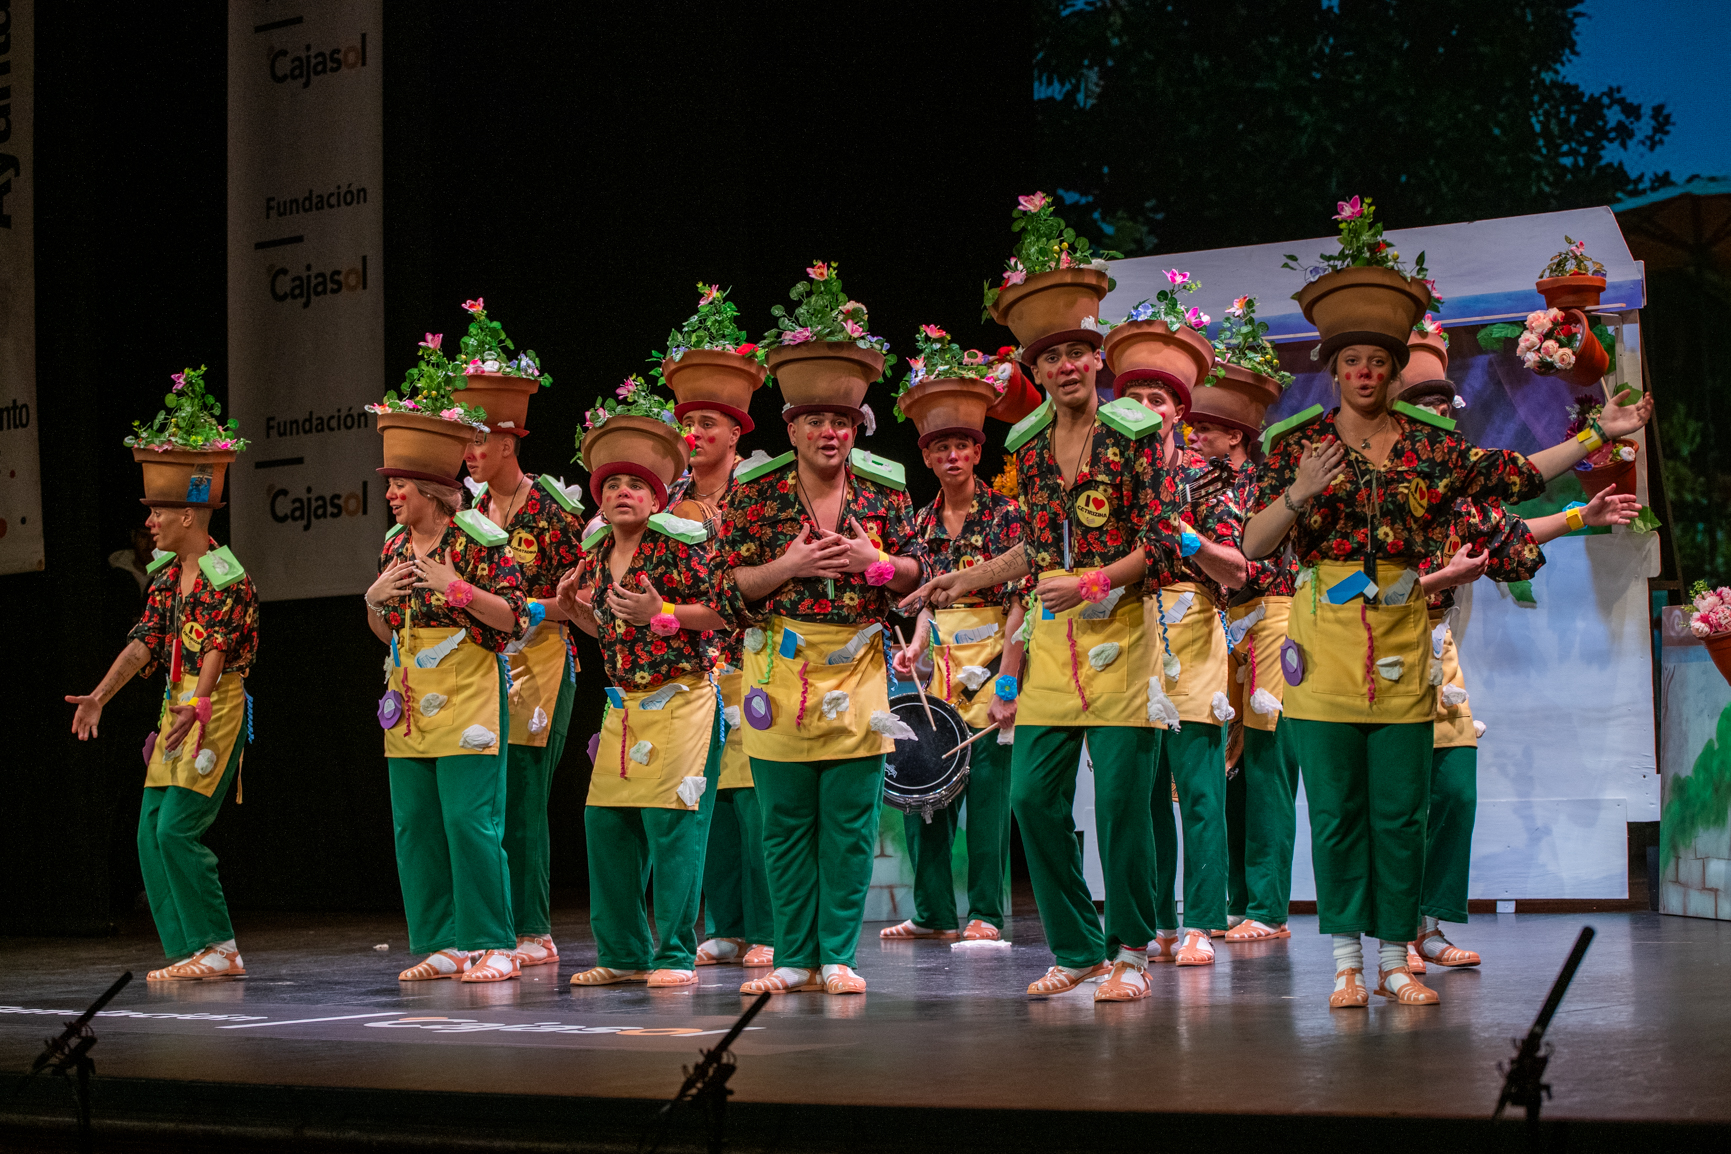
left=0, top=0, right=43, bottom=573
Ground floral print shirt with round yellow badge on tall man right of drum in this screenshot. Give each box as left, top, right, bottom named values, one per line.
left=1016, top=420, right=1179, bottom=580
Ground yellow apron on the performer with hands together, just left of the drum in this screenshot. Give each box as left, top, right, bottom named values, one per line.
left=743, top=614, right=895, bottom=763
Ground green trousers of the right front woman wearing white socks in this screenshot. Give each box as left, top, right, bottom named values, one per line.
left=1281, top=718, right=1433, bottom=941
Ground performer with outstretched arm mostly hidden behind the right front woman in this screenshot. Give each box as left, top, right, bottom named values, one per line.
left=1399, top=365, right=1641, bottom=974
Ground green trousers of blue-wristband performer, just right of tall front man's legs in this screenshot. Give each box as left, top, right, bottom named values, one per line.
left=1153, top=721, right=1227, bottom=931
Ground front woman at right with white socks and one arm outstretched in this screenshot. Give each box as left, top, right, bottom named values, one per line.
left=1245, top=304, right=1651, bottom=1007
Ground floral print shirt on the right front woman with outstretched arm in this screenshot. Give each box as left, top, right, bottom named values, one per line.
left=1255, top=408, right=1544, bottom=566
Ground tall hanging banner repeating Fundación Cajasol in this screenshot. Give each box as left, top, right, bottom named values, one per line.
left=227, top=0, right=389, bottom=600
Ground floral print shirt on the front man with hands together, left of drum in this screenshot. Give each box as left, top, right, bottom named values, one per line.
left=717, top=460, right=919, bottom=625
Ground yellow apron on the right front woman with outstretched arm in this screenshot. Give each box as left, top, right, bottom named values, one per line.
left=1284, top=561, right=1437, bottom=725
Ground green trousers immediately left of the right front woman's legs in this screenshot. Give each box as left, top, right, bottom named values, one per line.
left=1226, top=721, right=1298, bottom=926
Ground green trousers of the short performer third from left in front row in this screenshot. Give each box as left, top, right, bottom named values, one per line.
left=583, top=709, right=722, bottom=971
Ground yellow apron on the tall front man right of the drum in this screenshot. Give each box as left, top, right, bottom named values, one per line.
left=1016, top=569, right=1149, bottom=728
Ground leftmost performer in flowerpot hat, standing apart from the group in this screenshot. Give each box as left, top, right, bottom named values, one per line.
left=66, top=380, right=258, bottom=981
